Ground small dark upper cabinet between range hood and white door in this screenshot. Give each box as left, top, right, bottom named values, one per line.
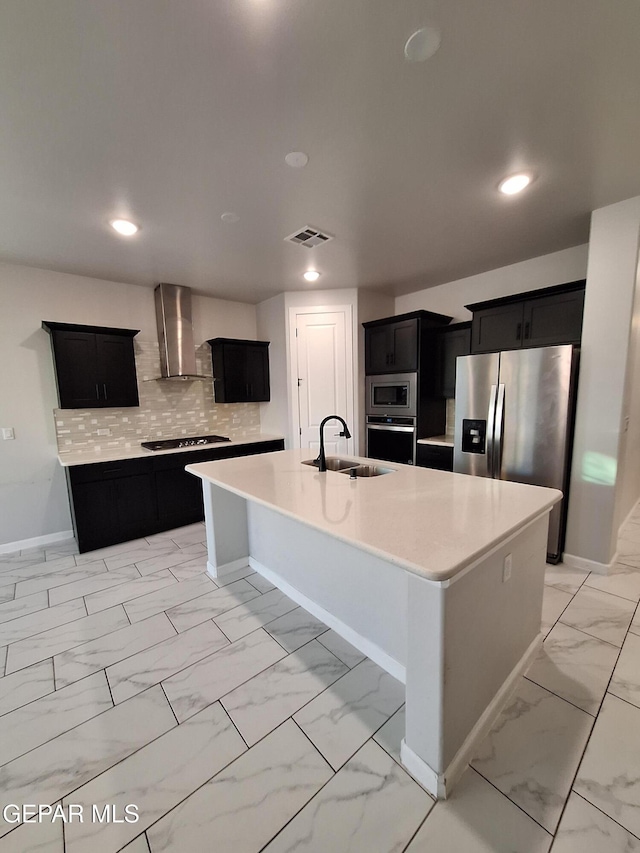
left=207, top=338, right=270, bottom=403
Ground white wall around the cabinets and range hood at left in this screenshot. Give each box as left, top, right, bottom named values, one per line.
left=0, top=264, right=256, bottom=545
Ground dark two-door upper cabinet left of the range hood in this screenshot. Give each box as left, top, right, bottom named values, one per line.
left=42, top=321, right=140, bottom=409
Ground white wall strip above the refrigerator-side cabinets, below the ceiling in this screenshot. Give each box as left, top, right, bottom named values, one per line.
left=394, top=245, right=588, bottom=323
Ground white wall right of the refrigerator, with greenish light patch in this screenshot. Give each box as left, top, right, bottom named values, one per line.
left=565, top=198, right=640, bottom=565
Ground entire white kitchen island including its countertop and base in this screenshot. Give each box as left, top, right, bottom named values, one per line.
left=187, top=450, right=561, bottom=797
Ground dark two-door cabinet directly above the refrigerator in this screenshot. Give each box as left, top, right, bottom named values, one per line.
left=466, top=280, right=585, bottom=353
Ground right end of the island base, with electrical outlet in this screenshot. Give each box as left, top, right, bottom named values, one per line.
left=405, top=515, right=548, bottom=797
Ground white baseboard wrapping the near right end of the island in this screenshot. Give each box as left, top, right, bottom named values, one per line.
left=400, top=634, right=543, bottom=800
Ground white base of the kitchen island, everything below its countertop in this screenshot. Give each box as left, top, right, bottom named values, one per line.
left=198, top=472, right=548, bottom=797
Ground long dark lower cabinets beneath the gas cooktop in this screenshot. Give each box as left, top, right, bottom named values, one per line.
left=66, top=440, right=284, bottom=553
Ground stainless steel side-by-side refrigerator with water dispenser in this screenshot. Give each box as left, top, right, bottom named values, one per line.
left=453, top=345, right=579, bottom=562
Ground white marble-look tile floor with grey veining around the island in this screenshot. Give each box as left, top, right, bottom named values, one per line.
left=0, top=510, right=640, bottom=853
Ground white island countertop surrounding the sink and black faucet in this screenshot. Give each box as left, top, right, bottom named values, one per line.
left=187, top=450, right=562, bottom=581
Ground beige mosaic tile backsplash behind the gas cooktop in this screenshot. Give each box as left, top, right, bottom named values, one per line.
left=54, top=341, right=260, bottom=454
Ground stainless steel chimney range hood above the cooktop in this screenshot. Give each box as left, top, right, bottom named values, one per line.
left=155, top=284, right=211, bottom=380
